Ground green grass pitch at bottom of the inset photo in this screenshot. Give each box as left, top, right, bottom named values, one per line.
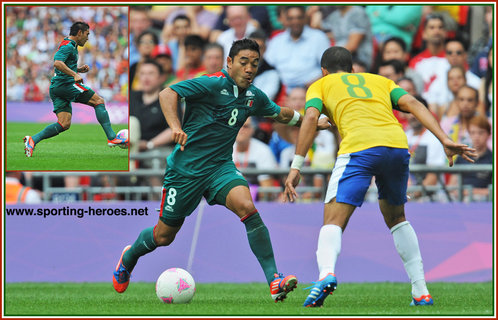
left=5, top=122, right=128, bottom=171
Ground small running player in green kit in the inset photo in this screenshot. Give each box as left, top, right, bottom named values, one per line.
left=24, top=21, right=128, bottom=157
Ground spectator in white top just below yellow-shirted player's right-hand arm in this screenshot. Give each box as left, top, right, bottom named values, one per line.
left=406, top=97, right=446, bottom=198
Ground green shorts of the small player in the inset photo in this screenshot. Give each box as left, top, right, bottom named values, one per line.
left=49, top=83, right=95, bottom=114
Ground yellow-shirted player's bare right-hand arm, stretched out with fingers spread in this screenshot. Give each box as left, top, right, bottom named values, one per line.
left=398, top=94, right=477, bottom=167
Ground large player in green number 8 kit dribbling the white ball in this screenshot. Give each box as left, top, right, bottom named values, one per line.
left=113, top=39, right=330, bottom=301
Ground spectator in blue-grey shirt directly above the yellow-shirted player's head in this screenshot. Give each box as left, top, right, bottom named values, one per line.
left=322, top=6, right=374, bottom=70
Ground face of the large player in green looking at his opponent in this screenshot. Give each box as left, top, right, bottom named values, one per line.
left=227, top=49, right=259, bottom=89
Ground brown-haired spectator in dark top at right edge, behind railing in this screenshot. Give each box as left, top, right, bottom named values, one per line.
left=449, top=116, right=493, bottom=200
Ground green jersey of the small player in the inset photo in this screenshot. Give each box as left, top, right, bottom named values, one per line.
left=50, top=38, right=78, bottom=88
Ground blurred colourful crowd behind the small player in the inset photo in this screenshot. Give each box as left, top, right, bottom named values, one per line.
left=4, top=6, right=128, bottom=102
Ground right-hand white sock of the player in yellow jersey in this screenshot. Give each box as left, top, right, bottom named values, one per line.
left=391, top=221, right=429, bottom=298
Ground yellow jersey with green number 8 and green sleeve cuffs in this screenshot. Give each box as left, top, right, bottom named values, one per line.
left=306, top=73, right=408, bottom=154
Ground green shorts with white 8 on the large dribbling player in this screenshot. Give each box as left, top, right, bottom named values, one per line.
left=159, top=161, right=249, bottom=227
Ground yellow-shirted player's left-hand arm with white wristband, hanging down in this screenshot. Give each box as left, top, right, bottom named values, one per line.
left=284, top=108, right=320, bottom=202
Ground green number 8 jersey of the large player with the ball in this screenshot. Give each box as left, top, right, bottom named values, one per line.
left=168, top=70, right=280, bottom=177
